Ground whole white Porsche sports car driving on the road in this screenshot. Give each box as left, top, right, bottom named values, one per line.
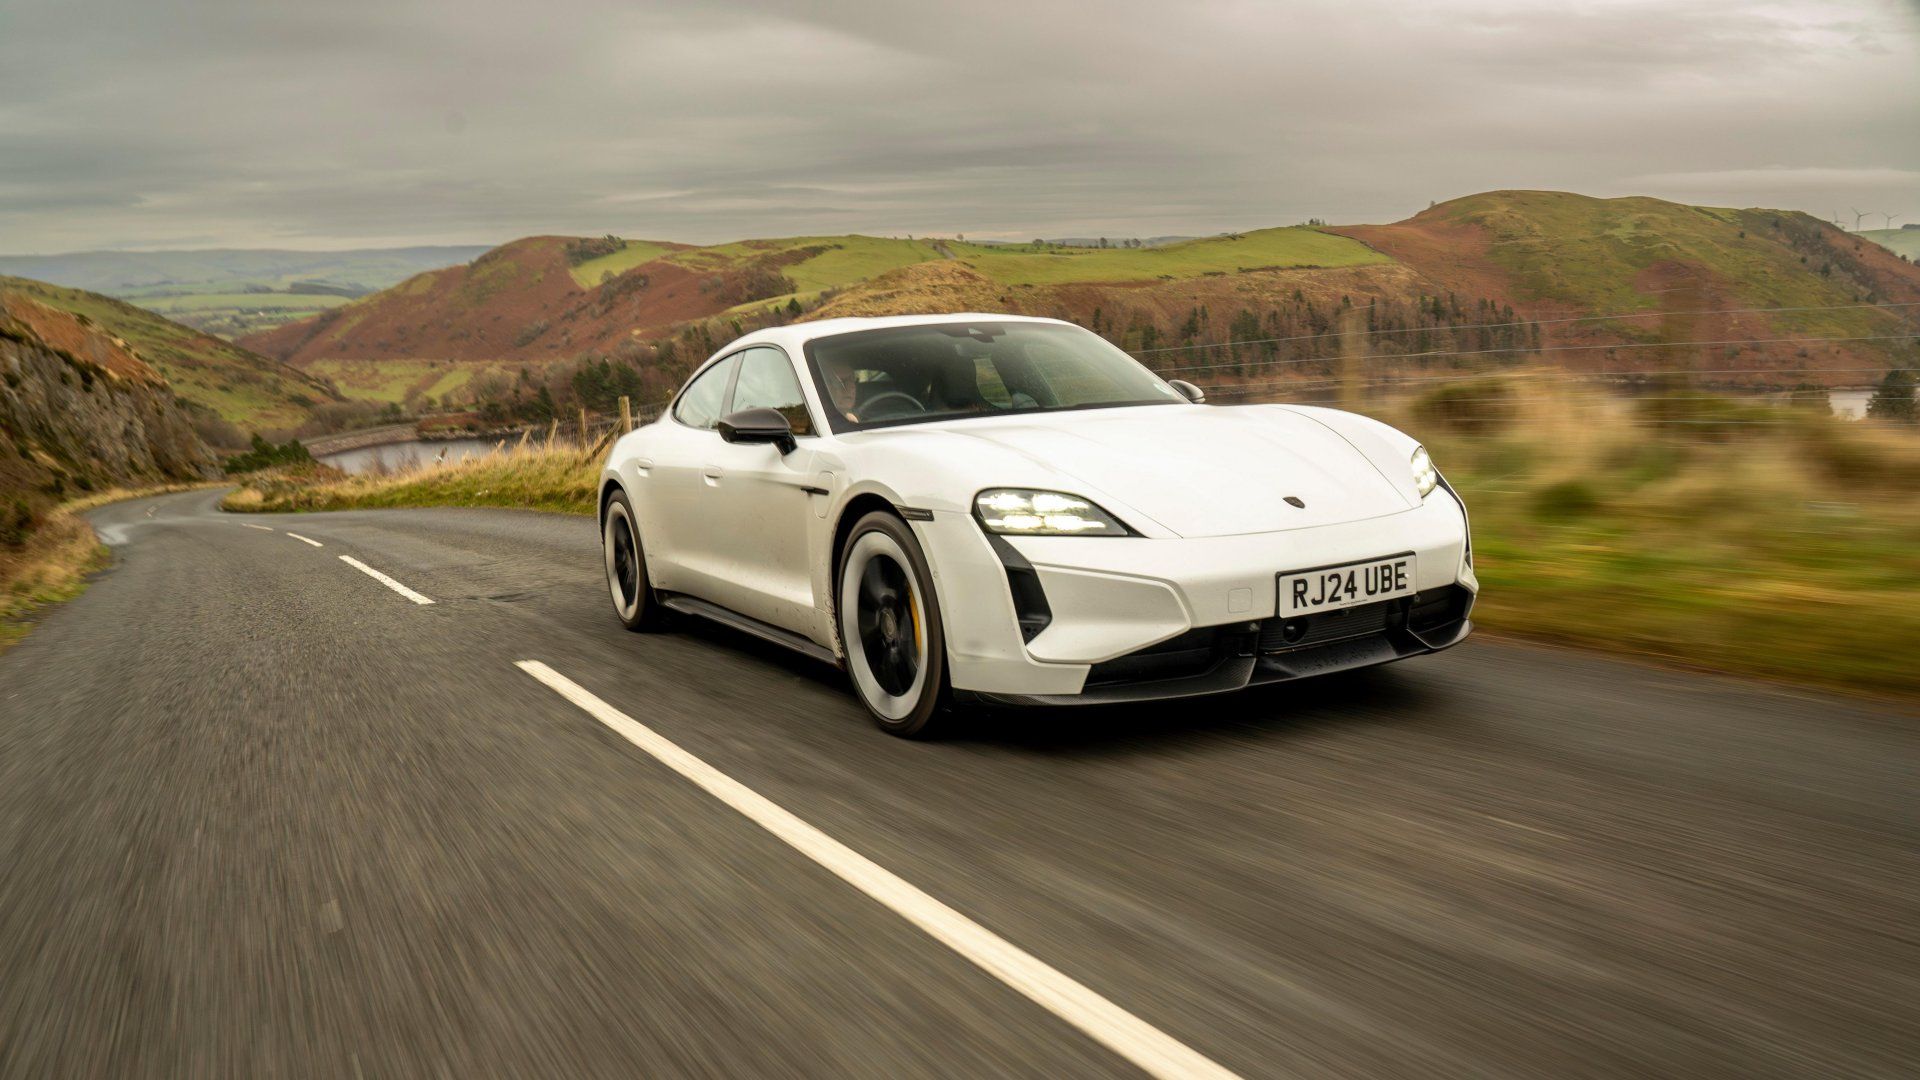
left=599, top=315, right=1478, bottom=736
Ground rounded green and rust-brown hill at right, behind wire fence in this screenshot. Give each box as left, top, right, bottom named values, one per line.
left=1332, top=190, right=1920, bottom=382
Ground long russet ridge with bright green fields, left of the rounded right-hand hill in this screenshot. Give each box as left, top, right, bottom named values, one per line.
left=242, top=229, right=1388, bottom=365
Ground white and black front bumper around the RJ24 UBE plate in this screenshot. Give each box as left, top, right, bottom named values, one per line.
left=914, top=488, right=1478, bottom=705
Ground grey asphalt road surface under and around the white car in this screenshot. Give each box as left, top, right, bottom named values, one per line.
left=0, top=492, right=1920, bottom=1078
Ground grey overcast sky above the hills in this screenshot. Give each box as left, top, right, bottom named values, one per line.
left=0, top=0, right=1920, bottom=254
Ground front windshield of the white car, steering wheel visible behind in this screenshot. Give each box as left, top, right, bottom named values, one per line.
left=806, top=321, right=1185, bottom=432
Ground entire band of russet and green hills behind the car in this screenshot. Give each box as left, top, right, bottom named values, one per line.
left=244, top=192, right=1920, bottom=400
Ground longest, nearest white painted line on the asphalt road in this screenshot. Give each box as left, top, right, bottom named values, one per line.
left=515, top=659, right=1235, bottom=1080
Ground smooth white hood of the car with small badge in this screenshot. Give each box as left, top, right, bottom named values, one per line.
left=929, top=405, right=1417, bottom=536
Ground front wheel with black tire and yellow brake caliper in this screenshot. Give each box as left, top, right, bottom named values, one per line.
left=833, top=511, right=947, bottom=738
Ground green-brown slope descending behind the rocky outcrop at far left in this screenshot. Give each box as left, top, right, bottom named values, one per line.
left=0, top=277, right=338, bottom=430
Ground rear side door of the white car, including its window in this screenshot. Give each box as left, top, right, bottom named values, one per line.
left=636, top=354, right=739, bottom=591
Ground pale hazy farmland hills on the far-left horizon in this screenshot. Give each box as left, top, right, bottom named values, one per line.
left=0, top=246, right=486, bottom=338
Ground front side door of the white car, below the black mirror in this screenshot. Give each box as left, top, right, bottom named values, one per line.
left=701, top=346, right=822, bottom=634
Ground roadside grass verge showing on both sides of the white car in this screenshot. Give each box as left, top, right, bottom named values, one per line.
left=228, top=379, right=1920, bottom=698
